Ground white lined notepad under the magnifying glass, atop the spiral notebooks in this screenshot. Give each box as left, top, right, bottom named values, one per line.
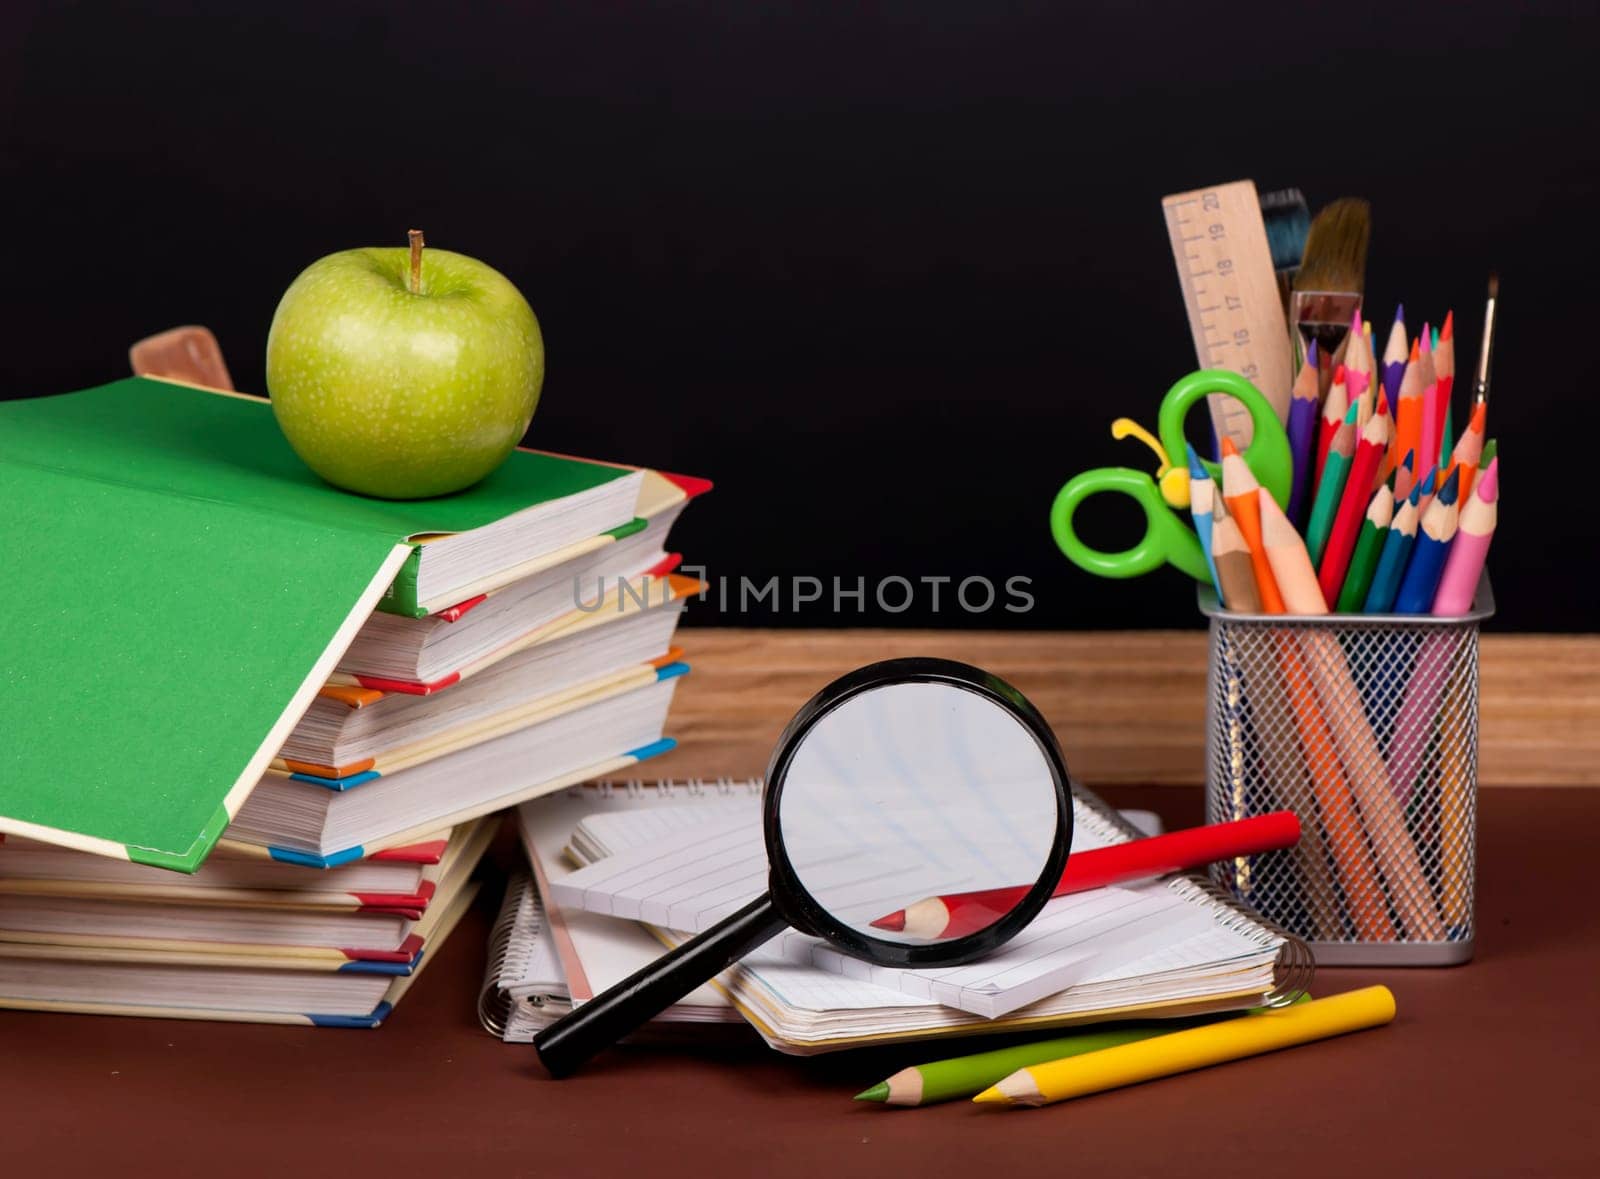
left=549, top=800, right=1280, bottom=1019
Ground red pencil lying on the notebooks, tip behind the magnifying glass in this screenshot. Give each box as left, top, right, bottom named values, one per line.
left=872, top=811, right=1299, bottom=937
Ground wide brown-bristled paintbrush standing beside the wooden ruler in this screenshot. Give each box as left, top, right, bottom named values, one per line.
left=1290, top=197, right=1373, bottom=389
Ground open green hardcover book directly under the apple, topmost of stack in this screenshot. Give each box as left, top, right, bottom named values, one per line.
left=0, top=378, right=642, bottom=872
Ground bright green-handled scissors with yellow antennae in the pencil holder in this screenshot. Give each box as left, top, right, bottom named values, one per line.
left=1050, top=368, right=1294, bottom=582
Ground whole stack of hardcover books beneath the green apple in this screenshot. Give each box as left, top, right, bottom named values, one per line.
left=0, top=379, right=709, bottom=1025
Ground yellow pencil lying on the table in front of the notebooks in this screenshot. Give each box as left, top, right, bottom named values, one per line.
left=973, top=987, right=1395, bottom=1105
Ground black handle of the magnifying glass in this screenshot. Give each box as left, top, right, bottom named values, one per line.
left=533, top=893, right=789, bottom=1077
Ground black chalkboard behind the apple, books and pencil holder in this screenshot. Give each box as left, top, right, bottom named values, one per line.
left=0, top=0, right=1600, bottom=630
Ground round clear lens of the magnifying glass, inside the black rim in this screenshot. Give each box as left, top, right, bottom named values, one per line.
left=778, top=681, right=1059, bottom=945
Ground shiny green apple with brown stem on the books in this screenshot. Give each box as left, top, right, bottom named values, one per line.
left=267, top=230, right=544, bottom=499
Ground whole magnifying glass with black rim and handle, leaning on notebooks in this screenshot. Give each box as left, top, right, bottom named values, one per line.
left=533, top=659, right=1072, bottom=1077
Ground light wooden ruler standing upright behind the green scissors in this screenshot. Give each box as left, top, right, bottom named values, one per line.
left=1162, top=181, right=1294, bottom=444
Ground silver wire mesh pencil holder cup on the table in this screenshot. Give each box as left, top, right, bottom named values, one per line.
left=1200, top=578, right=1494, bottom=966
